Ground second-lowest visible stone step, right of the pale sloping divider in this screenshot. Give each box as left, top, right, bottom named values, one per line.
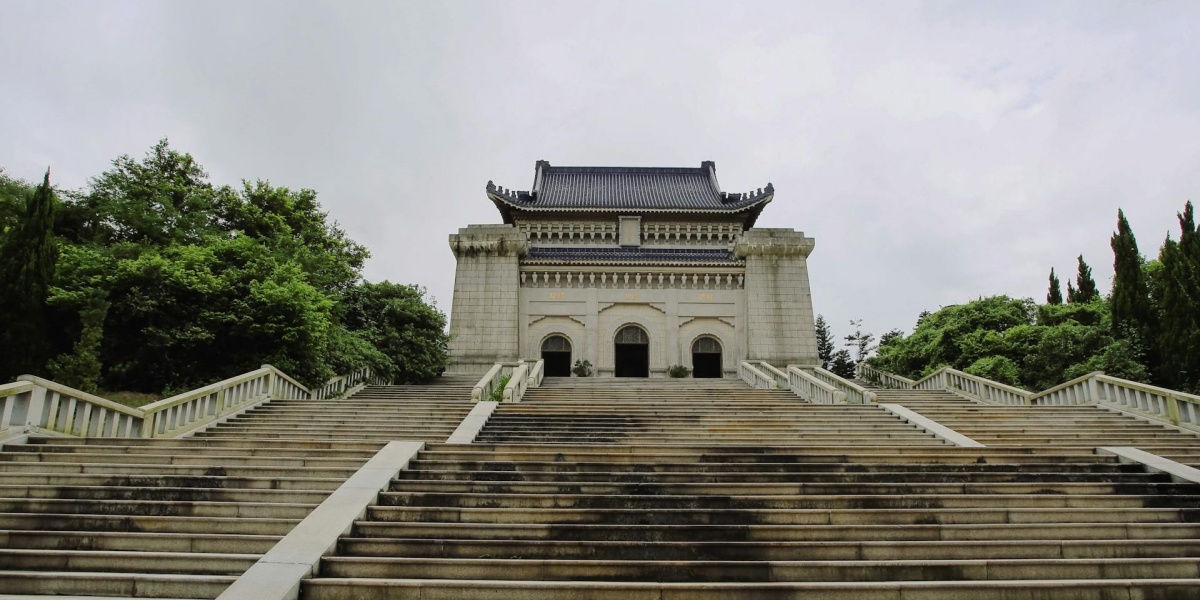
left=320, top=557, right=1200, bottom=583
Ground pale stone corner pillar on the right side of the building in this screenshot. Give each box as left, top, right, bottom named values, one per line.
left=734, top=229, right=821, bottom=370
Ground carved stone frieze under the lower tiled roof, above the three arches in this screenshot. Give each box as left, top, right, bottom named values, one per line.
left=521, top=270, right=745, bottom=289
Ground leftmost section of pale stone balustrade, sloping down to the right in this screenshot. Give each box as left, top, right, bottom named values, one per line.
left=0, top=376, right=143, bottom=438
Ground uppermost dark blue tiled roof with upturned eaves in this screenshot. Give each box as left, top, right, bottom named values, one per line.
left=487, top=161, right=775, bottom=217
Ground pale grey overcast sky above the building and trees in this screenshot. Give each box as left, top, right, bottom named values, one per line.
left=0, top=0, right=1200, bottom=343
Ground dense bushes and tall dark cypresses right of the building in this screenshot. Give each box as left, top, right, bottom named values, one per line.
left=871, top=203, right=1200, bottom=391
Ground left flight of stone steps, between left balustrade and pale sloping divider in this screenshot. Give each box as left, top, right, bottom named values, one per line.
left=0, top=379, right=474, bottom=599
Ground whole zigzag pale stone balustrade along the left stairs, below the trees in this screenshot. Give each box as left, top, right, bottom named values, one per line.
left=0, top=365, right=372, bottom=438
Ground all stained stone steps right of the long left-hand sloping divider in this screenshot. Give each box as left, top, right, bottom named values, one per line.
left=301, top=380, right=1200, bottom=600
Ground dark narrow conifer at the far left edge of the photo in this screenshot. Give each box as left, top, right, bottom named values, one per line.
left=0, top=169, right=58, bottom=382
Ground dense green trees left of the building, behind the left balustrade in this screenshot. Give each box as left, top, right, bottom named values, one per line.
left=0, top=140, right=446, bottom=392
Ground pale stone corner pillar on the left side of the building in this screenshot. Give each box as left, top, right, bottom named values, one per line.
left=446, top=224, right=528, bottom=376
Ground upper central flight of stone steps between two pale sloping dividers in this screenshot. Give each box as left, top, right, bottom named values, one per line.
left=475, top=378, right=944, bottom=449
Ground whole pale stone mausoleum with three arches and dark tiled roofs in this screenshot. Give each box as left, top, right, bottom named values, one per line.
left=450, top=161, right=817, bottom=377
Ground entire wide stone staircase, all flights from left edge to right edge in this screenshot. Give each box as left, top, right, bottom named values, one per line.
left=7, top=378, right=1200, bottom=600
